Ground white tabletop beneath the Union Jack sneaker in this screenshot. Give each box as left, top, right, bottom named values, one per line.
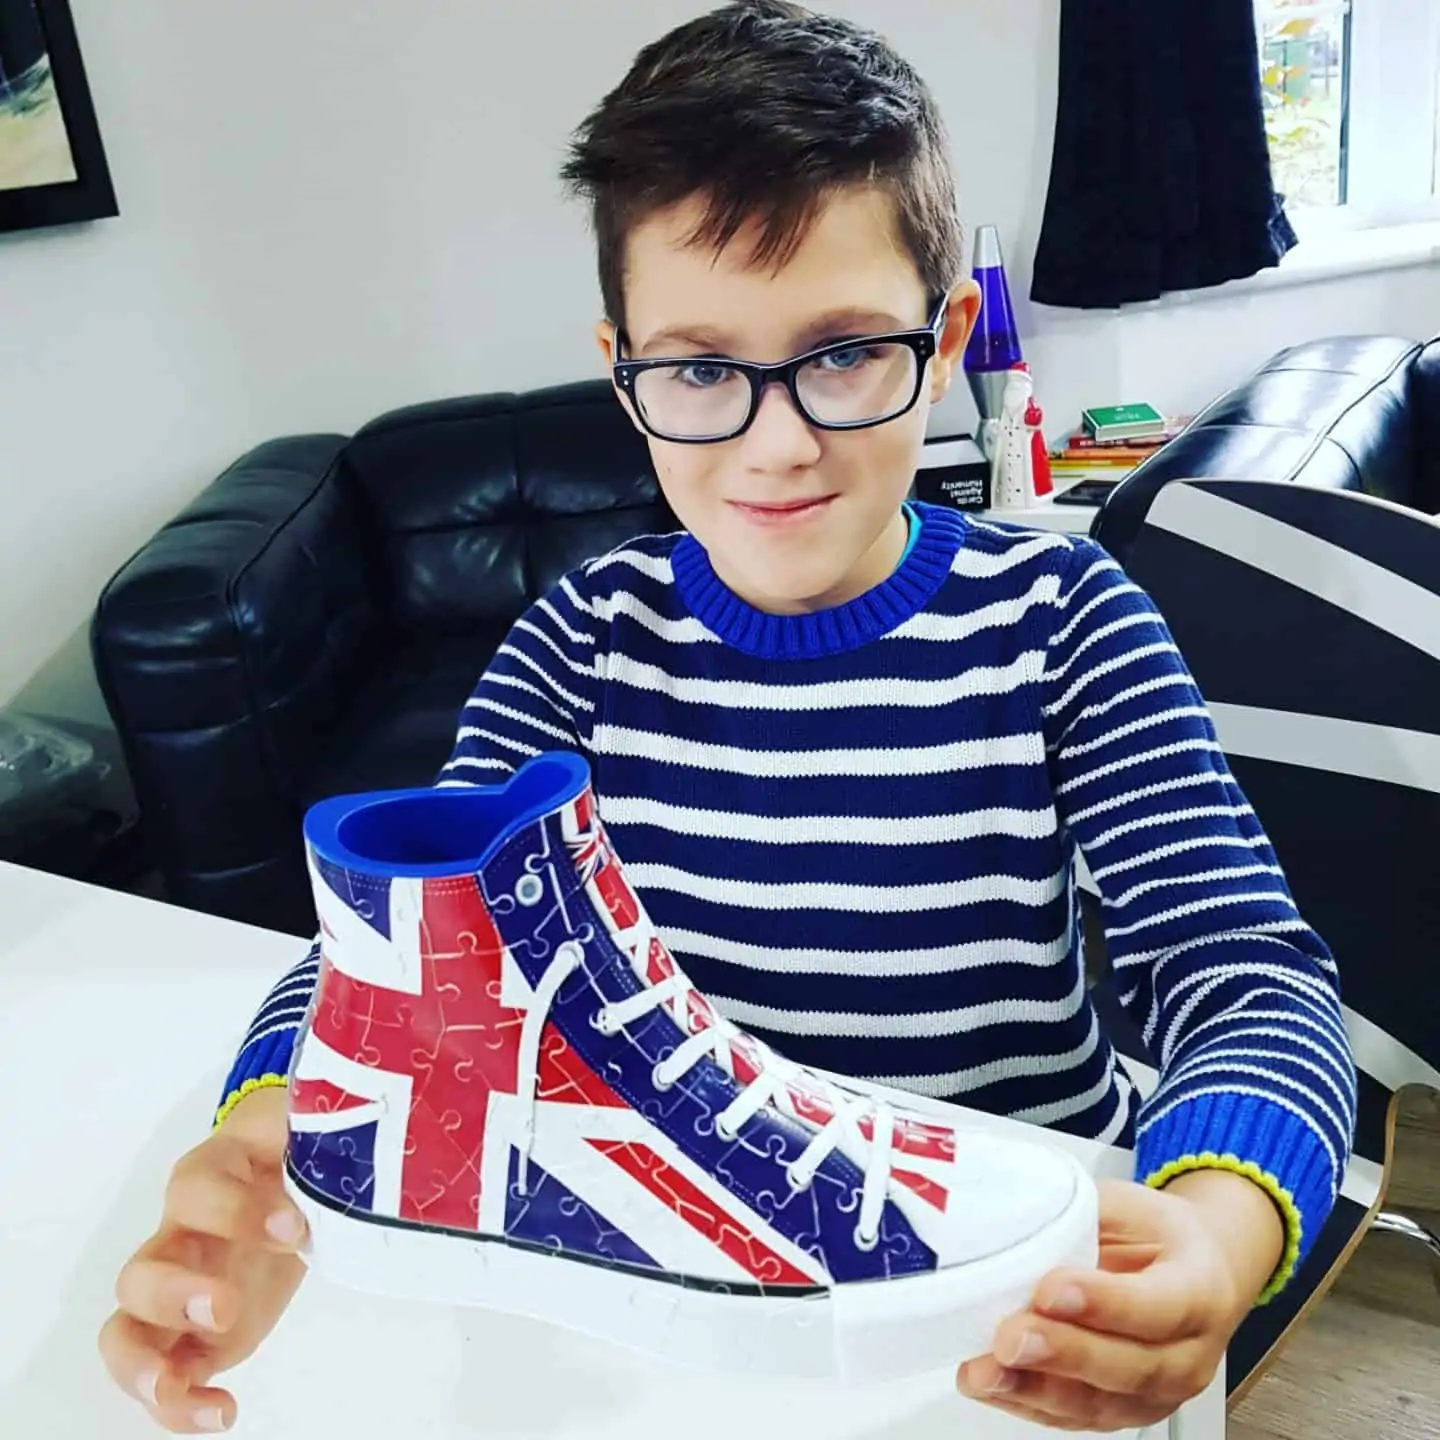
left=0, top=864, right=1224, bottom=1440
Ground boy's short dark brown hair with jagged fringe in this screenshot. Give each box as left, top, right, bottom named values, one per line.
left=562, top=0, right=965, bottom=327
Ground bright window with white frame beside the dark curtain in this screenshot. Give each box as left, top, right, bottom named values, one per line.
left=1256, top=0, right=1440, bottom=235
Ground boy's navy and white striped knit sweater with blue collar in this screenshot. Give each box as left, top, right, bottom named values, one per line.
left=222, top=507, right=1355, bottom=1293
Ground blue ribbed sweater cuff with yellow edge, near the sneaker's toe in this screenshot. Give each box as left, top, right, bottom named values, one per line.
left=1135, top=1093, right=1338, bottom=1305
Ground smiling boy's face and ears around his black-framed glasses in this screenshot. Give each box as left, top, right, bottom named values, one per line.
left=598, top=186, right=979, bottom=613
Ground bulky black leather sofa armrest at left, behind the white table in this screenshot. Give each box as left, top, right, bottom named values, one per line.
left=91, top=435, right=377, bottom=926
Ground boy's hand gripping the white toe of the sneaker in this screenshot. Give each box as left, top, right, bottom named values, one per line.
left=959, top=1169, right=1284, bottom=1431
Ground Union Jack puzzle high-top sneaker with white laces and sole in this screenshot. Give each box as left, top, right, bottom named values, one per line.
left=287, top=753, right=1097, bottom=1380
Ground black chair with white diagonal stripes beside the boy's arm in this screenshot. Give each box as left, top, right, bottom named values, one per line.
left=1093, top=480, right=1440, bottom=1404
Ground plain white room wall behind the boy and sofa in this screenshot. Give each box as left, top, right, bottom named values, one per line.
left=0, top=0, right=1440, bottom=737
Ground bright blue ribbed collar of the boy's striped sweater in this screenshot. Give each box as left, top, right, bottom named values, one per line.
left=671, top=505, right=965, bottom=660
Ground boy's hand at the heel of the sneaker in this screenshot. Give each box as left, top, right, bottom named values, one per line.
left=99, top=1089, right=305, bottom=1434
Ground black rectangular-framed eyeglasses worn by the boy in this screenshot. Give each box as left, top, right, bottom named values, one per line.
left=612, top=297, right=949, bottom=445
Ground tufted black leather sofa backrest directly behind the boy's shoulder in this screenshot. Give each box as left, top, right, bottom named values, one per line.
left=340, top=380, right=675, bottom=638
